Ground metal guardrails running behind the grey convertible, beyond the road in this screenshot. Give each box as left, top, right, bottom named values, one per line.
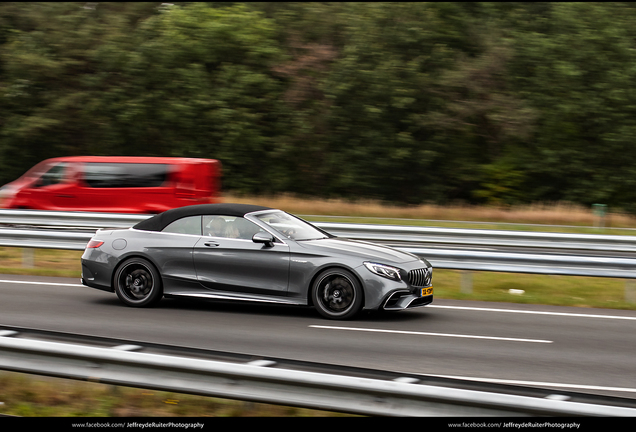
left=0, top=210, right=636, bottom=279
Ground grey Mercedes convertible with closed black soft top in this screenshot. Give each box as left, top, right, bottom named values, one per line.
left=82, top=204, right=433, bottom=319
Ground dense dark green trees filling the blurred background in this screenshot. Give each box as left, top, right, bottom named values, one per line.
left=0, top=2, right=636, bottom=211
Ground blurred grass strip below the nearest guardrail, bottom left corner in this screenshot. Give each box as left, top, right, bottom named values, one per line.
left=0, top=372, right=347, bottom=417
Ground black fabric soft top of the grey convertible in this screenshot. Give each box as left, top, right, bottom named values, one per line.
left=133, top=203, right=275, bottom=231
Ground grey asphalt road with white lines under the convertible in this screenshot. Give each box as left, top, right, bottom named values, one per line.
left=0, top=275, right=636, bottom=399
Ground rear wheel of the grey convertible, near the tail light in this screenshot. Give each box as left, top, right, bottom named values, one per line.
left=114, top=258, right=163, bottom=307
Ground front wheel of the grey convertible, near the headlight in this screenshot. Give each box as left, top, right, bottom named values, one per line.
left=311, top=269, right=364, bottom=320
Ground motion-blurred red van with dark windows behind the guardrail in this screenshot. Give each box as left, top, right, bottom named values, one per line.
left=0, top=156, right=221, bottom=213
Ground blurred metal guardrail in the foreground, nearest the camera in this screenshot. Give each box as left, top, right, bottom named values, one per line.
left=0, top=331, right=636, bottom=417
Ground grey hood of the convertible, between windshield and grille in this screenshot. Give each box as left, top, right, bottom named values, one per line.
left=298, top=237, right=419, bottom=264
